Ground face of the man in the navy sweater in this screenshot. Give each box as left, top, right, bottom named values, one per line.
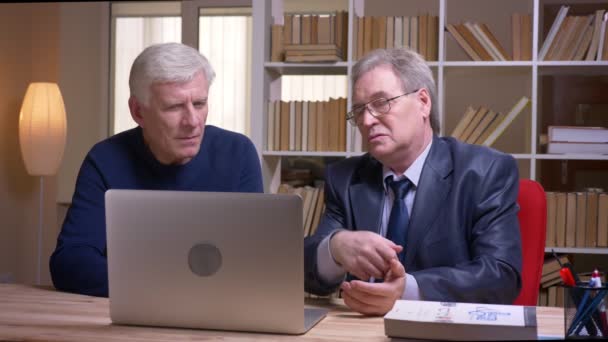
left=129, top=72, right=209, bottom=164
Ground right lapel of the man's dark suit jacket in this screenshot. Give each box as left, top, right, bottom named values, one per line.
left=405, top=137, right=453, bottom=271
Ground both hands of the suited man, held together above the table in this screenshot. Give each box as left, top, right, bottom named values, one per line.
left=330, top=230, right=406, bottom=315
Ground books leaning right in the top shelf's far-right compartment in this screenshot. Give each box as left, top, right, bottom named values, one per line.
left=538, top=5, right=608, bottom=61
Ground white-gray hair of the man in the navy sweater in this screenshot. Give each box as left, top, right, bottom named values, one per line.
left=129, top=43, right=215, bottom=105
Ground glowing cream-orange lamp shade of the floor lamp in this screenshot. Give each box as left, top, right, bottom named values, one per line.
left=19, top=82, right=67, bottom=176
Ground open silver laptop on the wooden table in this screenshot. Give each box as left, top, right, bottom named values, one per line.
left=105, top=190, right=326, bottom=334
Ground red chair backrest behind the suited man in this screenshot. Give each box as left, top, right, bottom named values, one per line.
left=513, top=179, right=547, bottom=306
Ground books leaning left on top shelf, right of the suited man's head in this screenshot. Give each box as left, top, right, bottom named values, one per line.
left=447, top=22, right=512, bottom=61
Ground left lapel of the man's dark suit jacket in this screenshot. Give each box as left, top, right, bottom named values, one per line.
left=349, top=155, right=384, bottom=233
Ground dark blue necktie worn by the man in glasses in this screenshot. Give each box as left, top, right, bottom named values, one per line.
left=386, top=176, right=412, bottom=263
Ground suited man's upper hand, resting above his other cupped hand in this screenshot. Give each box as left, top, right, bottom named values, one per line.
left=329, top=230, right=403, bottom=280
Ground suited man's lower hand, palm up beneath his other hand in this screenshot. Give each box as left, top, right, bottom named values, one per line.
left=340, top=258, right=405, bottom=316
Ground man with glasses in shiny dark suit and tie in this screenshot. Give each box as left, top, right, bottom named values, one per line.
left=304, top=49, right=522, bottom=315
